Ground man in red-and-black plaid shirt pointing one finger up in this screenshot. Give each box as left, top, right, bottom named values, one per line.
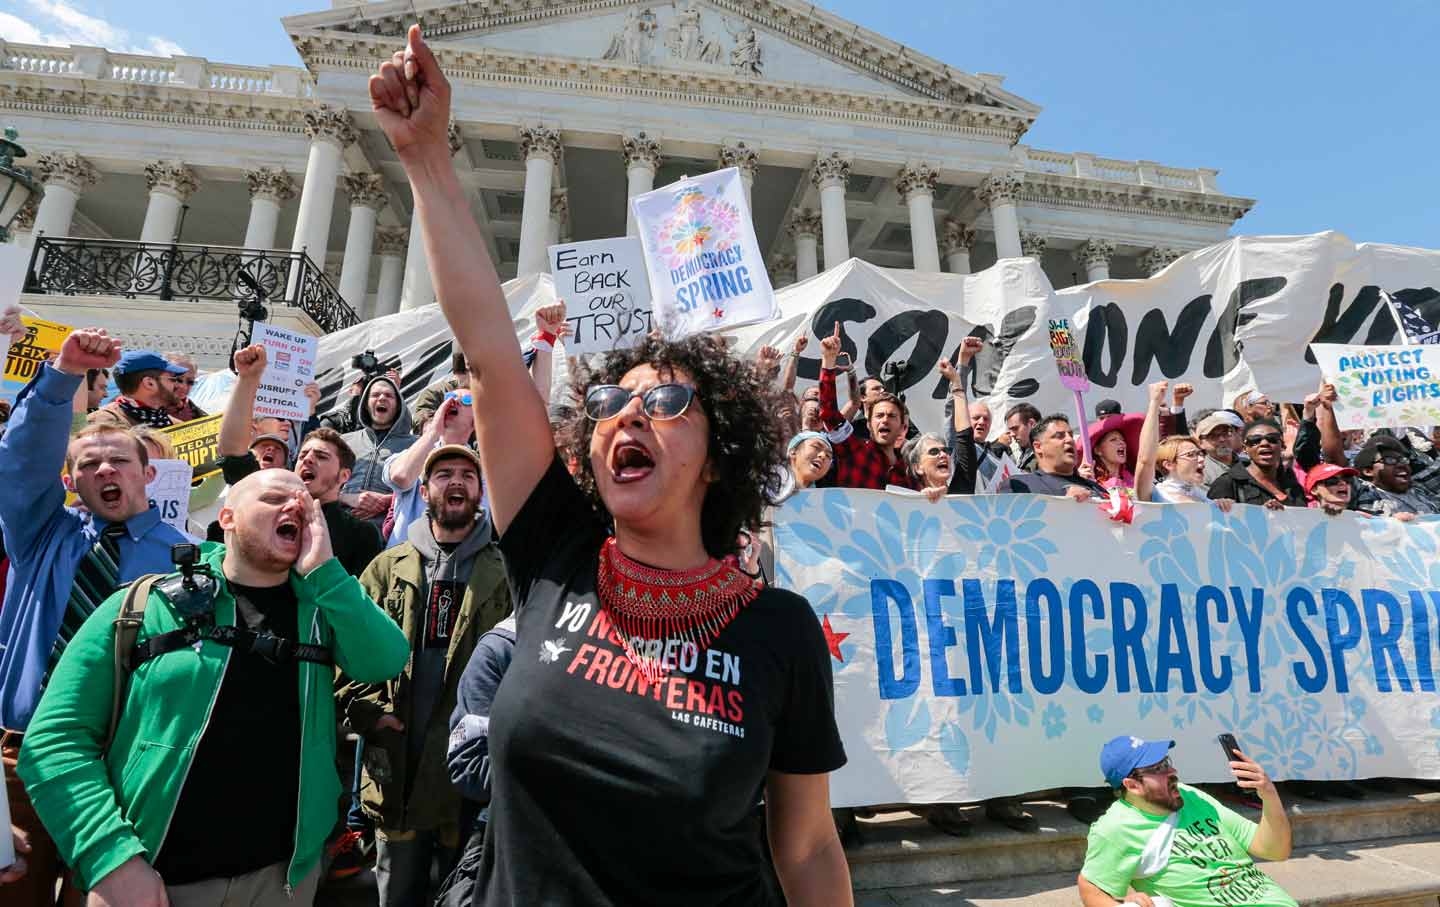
left=819, top=322, right=916, bottom=489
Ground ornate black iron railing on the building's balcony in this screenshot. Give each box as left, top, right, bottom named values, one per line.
left=24, top=236, right=360, bottom=334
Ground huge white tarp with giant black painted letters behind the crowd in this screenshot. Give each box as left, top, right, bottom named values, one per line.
left=318, top=233, right=1440, bottom=443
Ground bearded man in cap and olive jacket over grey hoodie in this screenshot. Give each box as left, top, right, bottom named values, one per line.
left=337, top=445, right=510, bottom=907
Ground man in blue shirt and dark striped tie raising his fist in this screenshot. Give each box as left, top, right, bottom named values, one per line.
left=0, top=330, right=186, bottom=904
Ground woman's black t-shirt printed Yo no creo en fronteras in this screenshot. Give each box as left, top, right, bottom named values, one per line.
left=477, top=459, right=845, bottom=907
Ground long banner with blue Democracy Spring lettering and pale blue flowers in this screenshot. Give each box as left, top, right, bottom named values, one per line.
left=775, top=489, right=1440, bottom=806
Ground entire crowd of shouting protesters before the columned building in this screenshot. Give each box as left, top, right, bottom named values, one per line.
left=0, top=23, right=1440, bottom=907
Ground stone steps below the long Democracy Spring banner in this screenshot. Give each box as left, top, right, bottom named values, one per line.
left=847, top=782, right=1440, bottom=907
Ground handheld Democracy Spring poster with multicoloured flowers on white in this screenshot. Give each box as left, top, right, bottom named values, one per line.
left=631, top=167, right=775, bottom=337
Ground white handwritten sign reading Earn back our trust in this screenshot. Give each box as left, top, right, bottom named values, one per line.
left=550, top=236, right=651, bottom=356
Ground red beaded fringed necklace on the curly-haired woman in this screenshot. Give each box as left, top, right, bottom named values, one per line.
left=596, top=537, right=765, bottom=682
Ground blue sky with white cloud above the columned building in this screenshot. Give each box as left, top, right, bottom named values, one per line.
left=8, top=0, right=1440, bottom=248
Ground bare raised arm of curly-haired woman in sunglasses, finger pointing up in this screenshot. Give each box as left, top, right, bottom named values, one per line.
left=370, top=26, right=554, bottom=534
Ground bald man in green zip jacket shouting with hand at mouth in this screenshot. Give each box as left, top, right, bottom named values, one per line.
left=20, top=469, right=410, bottom=907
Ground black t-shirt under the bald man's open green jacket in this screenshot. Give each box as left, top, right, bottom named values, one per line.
left=154, top=583, right=301, bottom=885
